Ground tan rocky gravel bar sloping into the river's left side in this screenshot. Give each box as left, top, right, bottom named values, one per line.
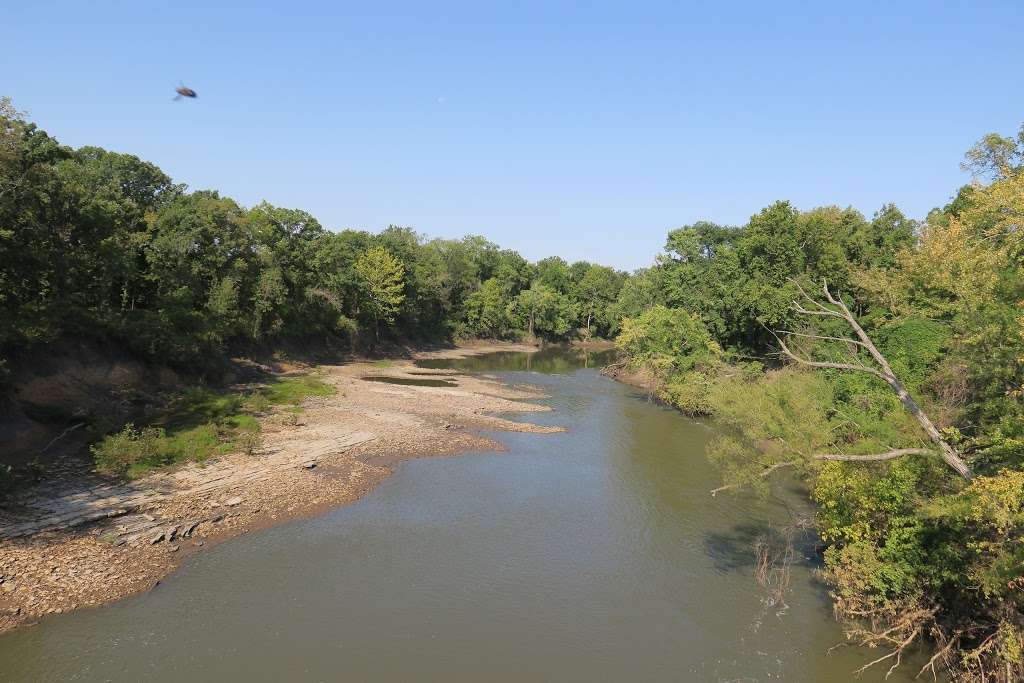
left=0, top=344, right=559, bottom=632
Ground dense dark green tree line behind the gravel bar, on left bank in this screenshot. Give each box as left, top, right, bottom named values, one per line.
left=0, top=98, right=627, bottom=385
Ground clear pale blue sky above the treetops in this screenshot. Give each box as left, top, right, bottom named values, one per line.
left=0, top=0, right=1024, bottom=268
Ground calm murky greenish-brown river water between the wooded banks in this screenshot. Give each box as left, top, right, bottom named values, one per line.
left=0, top=349, right=929, bottom=683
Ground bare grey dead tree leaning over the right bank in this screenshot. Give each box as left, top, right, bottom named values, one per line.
left=772, top=281, right=971, bottom=479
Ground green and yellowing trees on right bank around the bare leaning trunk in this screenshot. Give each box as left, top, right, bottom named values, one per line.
left=616, top=128, right=1024, bottom=682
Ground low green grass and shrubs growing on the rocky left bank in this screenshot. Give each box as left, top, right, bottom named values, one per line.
left=91, top=375, right=335, bottom=478
